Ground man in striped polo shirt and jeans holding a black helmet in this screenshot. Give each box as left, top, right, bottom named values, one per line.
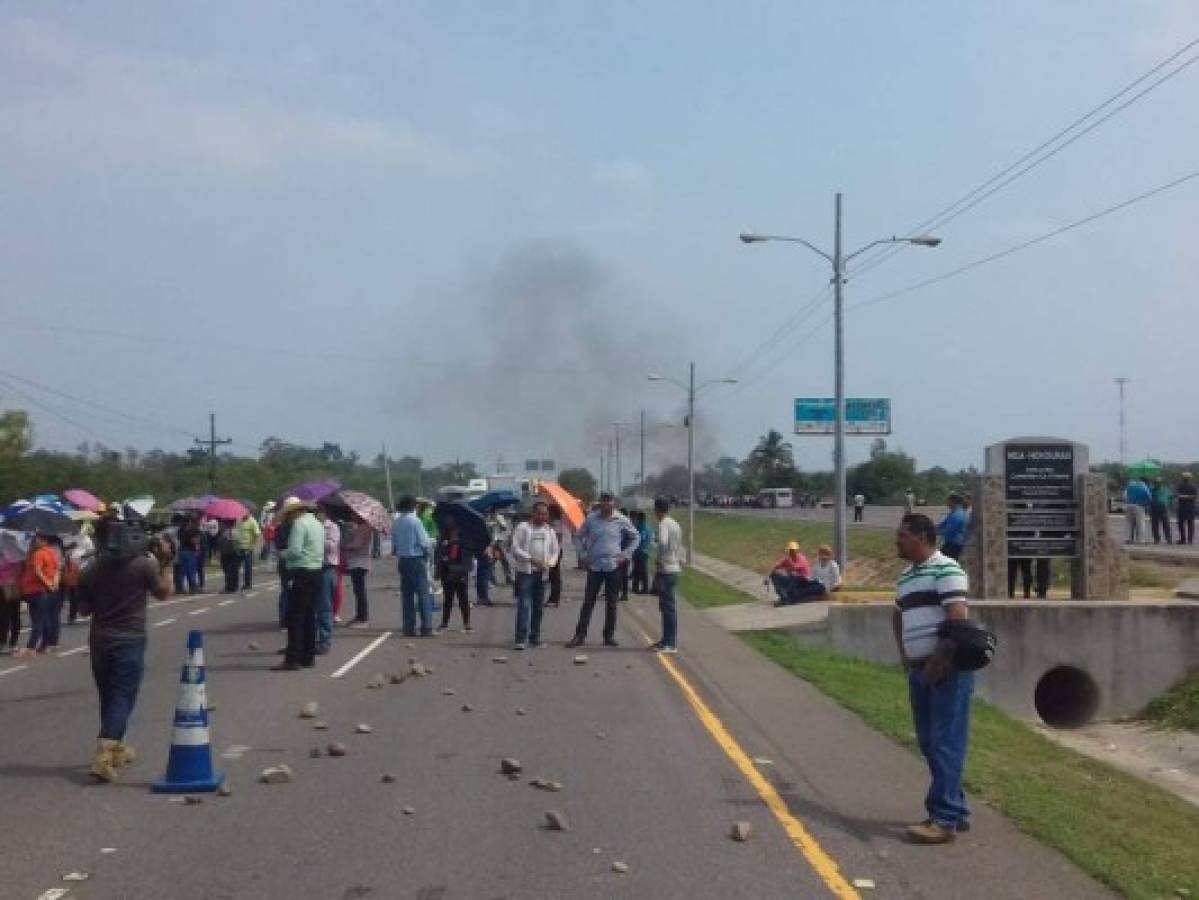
left=892, top=513, right=974, bottom=844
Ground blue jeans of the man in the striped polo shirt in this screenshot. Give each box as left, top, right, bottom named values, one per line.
left=908, top=669, right=974, bottom=828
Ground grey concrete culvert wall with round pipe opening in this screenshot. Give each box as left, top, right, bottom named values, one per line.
left=829, top=600, right=1199, bottom=719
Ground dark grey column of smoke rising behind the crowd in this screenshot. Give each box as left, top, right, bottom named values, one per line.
left=460, top=241, right=715, bottom=484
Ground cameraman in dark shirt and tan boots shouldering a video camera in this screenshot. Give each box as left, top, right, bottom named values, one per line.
left=79, top=520, right=174, bottom=781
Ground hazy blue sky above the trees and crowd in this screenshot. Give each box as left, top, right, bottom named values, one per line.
left=0, top=0, right=1199, bottom=472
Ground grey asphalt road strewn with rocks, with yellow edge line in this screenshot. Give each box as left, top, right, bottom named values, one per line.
left=0, top=561, right=1105, bottom=900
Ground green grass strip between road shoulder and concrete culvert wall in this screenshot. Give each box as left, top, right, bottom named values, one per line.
left=741, top=632, right=1199, bottom=899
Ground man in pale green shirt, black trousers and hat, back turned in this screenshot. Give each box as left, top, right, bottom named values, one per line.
left=271, top=497, right=325, bottom=672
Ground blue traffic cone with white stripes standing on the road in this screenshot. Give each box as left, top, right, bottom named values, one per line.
left=151, top=632, right=224, bottom=793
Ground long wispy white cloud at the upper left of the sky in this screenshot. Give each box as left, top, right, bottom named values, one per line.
left=0, top=22, right=498, bottom=176
